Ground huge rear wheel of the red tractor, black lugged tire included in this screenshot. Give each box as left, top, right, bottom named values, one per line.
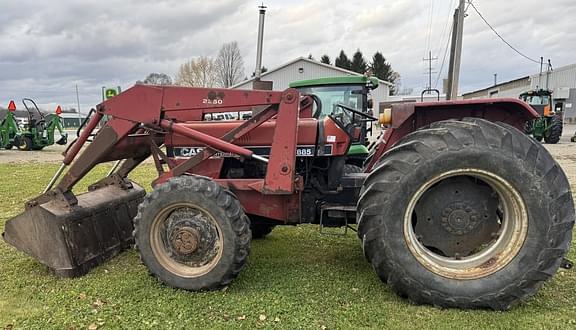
left=358, top=119, right=574, bottom=310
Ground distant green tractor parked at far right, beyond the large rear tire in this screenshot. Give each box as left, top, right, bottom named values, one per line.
left=520, top=89, right=563, bottom=144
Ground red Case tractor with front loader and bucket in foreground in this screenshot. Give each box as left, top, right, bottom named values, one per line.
left=3, top=85, right=574, bottom=309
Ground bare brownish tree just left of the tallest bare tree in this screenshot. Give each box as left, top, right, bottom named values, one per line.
left=176, top=56, right=216, bottom=87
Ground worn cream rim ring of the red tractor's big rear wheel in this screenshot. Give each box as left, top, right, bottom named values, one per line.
left=404, top=168, right=528, bottom=279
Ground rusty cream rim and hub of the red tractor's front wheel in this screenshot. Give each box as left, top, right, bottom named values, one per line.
left=150, top=202, right=224, bottom=278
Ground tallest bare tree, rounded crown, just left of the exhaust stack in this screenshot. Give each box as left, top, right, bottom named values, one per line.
left=216, top=41, right=244, bottom=88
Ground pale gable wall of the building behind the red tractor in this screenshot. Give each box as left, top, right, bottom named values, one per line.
left=236, top=60, right=389, bottom=105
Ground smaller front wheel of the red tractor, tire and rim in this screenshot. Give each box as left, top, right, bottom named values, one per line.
left=134, top=176, right=251, bottom=291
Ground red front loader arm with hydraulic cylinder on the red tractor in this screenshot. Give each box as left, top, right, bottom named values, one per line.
left=49, top=85, right=311, bottom=199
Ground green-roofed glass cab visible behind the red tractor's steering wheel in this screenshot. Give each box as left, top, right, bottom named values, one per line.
left=290, top=76, right=378, bottom=166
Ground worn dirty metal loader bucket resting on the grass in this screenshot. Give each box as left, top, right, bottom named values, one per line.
left=2, top=183, right=146, bottom=277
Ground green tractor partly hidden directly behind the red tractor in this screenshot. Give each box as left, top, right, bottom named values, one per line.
left=290, top=76, right=378, bottom=171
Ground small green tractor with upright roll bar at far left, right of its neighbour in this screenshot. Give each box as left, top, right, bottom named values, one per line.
left=15, top=99, right=68, bottom=151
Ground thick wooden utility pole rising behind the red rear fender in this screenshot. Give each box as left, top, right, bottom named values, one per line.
left=446, top=0, right=466, bottom=100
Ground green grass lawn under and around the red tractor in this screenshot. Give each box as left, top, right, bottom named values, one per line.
left=0, top=163, right=576, bottom=329
